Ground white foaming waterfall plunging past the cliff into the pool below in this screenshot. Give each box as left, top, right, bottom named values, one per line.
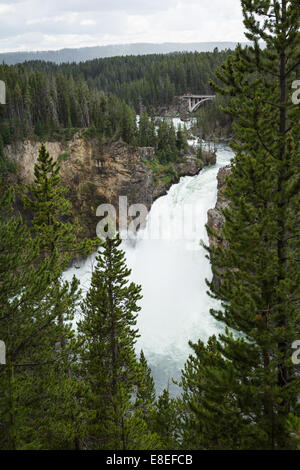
left=65, top=141, right=233, bottom=394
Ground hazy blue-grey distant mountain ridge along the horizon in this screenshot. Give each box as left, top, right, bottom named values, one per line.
left=0, top=42, right=246, bottom=65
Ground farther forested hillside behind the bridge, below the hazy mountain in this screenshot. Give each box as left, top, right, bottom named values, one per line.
left=19, top=49, right=229, bottom=111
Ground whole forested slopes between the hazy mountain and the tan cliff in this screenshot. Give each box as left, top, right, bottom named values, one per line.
left=0, top=50, right=228, bottom=156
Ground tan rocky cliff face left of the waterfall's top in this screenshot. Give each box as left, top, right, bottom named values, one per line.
left=6, top=135, right=216, bottom=237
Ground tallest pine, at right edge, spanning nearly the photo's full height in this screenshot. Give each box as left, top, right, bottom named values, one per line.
left=185, top=0, right=300, bottom=449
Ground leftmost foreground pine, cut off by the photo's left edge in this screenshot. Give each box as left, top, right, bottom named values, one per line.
left=0, top=190, right=43, bottom=449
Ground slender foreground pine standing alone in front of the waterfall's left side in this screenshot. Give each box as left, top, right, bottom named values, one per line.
left=78, top=235, right=152, bottom=450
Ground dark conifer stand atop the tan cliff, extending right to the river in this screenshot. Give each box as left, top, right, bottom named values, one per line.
left=0, top=54, right=192, bottom=175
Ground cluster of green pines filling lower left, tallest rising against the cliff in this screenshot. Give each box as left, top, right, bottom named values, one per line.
left=0, top=145, right=99, bottom=449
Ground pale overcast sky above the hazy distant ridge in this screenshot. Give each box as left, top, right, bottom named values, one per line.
left=0, top=0, right=245, bottom=52
